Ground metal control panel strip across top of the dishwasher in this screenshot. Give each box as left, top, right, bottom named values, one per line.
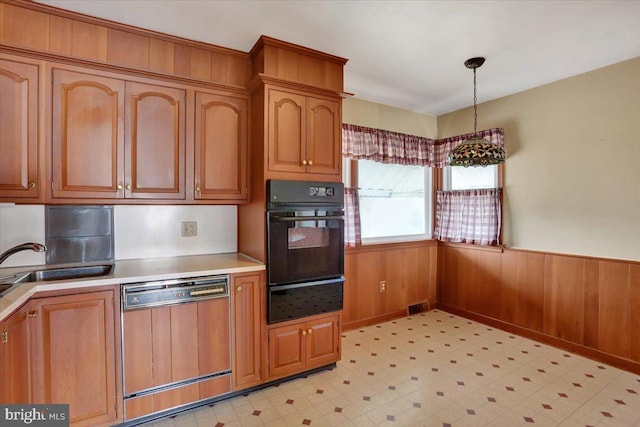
left=122, top=276, right=229, bottom=310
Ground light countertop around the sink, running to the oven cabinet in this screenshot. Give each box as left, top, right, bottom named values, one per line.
left=0, top=253, right=265, bottom=320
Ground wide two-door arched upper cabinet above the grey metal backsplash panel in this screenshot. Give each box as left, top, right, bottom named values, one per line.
left=51, top=69, right=186, bottom=199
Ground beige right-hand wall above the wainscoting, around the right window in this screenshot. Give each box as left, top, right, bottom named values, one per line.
left=438, top=57, right=640, bottom=260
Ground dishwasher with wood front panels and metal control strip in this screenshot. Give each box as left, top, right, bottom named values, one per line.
left=122, top=275, right=231, bottom=421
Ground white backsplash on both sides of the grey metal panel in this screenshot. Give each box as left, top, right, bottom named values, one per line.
left=0, top=205, right=238, bottom=267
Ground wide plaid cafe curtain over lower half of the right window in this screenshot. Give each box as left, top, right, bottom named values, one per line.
left=433, top=188, right=502, bottom=245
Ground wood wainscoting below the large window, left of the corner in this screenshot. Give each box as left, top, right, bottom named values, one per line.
left=342, top=240, right=438, bottom=330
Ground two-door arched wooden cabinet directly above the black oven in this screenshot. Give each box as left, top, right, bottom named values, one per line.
left=267, top=88, right=342, bottom=175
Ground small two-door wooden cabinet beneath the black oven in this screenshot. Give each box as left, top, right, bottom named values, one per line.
left=268, top=313, right=340, bottom=379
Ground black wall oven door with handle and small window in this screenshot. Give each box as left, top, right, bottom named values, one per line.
left=268, top=210, right=344, bottom=283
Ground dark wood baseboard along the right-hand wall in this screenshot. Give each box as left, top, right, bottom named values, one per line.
left=436, top=303, right=640, bottom=375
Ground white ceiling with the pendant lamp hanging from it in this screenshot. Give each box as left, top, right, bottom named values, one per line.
left=41, top=0, right=640, bottom=115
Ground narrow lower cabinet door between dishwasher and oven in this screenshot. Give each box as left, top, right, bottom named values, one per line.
left=231, top=274, right=263, bottom=390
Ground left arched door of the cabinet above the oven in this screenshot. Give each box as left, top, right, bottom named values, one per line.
left=268, top=89, right=307, bottom=172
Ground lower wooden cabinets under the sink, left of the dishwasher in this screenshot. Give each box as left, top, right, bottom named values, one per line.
left=0, top=291, right=118, bottom=426
